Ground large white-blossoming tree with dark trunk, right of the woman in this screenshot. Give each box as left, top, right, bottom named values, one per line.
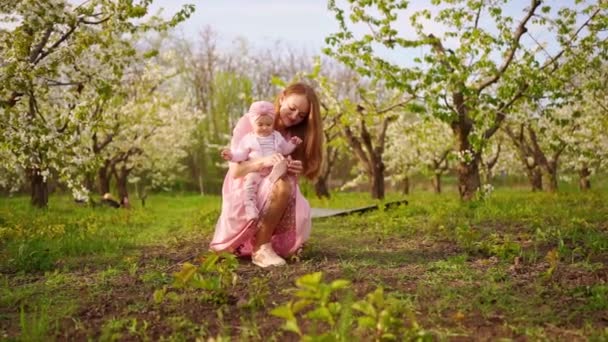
left=325, top=0, right=606, bottom=200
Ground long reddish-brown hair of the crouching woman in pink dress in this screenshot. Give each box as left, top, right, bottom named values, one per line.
left=274, top=83, right=323, bottom=180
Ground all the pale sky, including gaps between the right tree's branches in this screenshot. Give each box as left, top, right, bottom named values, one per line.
left=150, top=0, right=571, bottom=64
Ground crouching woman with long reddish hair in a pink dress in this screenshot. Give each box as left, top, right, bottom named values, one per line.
left=210, top=83, right=323, bottom=267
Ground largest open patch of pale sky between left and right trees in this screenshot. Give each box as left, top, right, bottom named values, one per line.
left=151, top=0, right=338, bottom=52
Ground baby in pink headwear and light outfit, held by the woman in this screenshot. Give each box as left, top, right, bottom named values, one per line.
left=221, top=101, right=302, bottom=220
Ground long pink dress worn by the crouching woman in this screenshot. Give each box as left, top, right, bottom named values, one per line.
left=209, top=116, right=311, bottom=256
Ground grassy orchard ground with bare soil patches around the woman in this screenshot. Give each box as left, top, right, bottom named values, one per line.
left=0, top=185, right=608, bottom=341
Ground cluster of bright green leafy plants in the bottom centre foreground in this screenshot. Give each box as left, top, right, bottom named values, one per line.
left=271, top=272, right=433, bottom=341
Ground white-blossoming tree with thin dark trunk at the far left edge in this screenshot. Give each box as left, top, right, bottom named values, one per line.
left=0, top=0, right=193, bottom=207
